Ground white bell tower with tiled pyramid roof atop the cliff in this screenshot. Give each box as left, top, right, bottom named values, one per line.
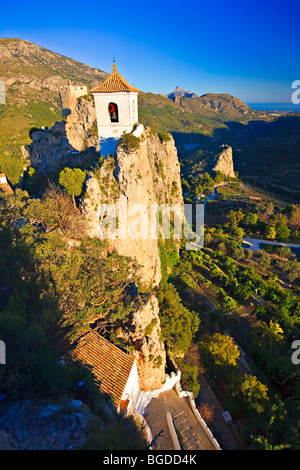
left=91, top=64, right=140, bottom=156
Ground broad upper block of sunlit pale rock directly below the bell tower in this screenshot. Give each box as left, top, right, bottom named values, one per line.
left=82, top=124, right=183, bottom=288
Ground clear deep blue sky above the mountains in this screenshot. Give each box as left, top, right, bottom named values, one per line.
left=0, top=0, right=300, bottom=103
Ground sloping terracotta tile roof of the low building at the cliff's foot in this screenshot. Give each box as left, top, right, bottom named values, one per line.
left=65, top=331, right=135, bottom=406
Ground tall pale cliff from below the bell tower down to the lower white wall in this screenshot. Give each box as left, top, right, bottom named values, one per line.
left=81, top=126, right=183, bottom=390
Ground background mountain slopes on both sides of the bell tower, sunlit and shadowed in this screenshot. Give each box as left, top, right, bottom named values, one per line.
left=0, top=34, right=299, bottom=200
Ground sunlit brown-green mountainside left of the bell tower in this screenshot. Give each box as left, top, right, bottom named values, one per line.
left=0, top=38, right=107, bottom=184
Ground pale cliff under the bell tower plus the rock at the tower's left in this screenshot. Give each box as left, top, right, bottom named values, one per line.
left=28, top=103, right=183, bottom=390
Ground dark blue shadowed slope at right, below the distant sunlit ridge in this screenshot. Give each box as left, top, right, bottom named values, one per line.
left=173, top=115, right=300, bottom=202
